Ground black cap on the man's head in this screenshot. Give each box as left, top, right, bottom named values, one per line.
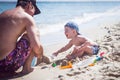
left=16, top=0, right=41, bottom=15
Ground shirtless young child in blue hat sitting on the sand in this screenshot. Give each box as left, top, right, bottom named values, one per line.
left=53, top=22, right=99, bottom=59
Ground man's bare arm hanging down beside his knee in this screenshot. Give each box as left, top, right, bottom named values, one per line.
left=26, top=15, right=43, bottom=57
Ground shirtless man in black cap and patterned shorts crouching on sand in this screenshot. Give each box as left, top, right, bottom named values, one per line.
left=0, top=0, right=43, bottom=74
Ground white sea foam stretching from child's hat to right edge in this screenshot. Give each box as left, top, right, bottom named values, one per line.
left=73, top=6, right=120, bottom=24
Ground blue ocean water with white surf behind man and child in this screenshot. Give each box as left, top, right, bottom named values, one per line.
left=0, top=1, right=120, bottom=44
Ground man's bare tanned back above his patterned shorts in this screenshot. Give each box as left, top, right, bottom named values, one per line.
left=0, top=8, right=26, bottom=60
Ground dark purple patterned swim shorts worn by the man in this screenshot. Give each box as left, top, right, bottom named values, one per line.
left=0, top=38, right=30, bottom=73
